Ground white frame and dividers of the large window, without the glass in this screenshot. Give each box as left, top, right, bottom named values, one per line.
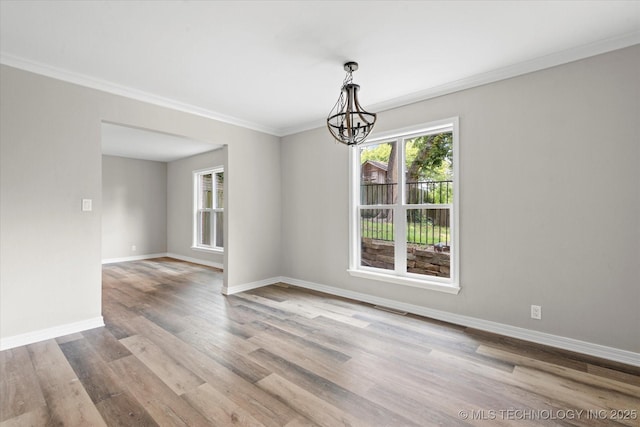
left=347, top=117, right=460, bottom=294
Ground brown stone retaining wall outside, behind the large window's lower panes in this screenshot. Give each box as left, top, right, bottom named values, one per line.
left=362, top=239, right=451, bottom=277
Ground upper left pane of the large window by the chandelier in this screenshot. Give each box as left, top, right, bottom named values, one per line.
left=360, top=142, right=398, bottom=205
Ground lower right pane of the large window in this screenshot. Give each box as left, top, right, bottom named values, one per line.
left=407, top=208, right=451, bottom=277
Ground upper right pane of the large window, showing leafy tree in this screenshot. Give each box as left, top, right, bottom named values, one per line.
left=405, top=132, right=453, bottom=204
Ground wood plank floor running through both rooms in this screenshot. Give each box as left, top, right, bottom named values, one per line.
left=0, top=258, right=640, bottom=427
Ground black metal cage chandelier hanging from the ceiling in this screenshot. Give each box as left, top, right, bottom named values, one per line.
left=327, top=62, right=376, bottom=145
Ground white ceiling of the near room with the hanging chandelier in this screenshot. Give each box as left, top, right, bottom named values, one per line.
left=0, top=0, right=640, bottom=136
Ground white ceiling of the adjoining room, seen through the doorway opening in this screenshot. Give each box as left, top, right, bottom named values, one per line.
left=102, top=123, right=222, bottom=162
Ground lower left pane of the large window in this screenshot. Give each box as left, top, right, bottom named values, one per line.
left=360, top=209, right=395, bottom=270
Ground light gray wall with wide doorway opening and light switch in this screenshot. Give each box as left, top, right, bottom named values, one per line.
left=0, top=65, right=281, bottom=339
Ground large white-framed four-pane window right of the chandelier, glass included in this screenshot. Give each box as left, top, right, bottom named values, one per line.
left=349, top=118, right=460, bottom=293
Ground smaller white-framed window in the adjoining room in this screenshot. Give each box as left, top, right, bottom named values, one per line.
left=193, top=167, right=224, bottom=251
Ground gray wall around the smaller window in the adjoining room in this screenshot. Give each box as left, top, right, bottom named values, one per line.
left=167, top=148, right=227, bottom=265
